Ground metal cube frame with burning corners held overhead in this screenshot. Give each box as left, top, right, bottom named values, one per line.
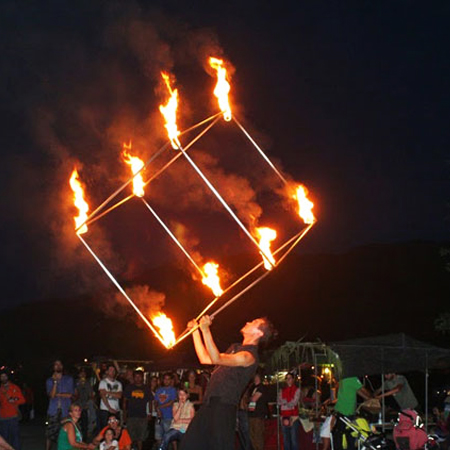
left=76, top=112, right=314, bottom=345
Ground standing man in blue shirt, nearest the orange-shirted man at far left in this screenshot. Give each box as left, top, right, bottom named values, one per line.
left=46, top=359, right=74, bottom=450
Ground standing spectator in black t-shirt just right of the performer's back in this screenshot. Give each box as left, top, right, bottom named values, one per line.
left=248, top=373, right=269, bottom=450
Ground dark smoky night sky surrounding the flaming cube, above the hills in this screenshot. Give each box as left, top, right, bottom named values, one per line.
left=0, top=0, right=450, bottom=305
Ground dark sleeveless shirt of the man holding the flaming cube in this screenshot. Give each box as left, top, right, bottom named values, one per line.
left=204, top=344, right=259, bottom=405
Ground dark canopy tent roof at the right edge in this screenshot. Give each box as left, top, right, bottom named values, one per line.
left=330, top=333, right=450, bottom=376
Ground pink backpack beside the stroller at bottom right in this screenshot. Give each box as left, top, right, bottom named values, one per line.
left=394, top=409, right=428, bottom=450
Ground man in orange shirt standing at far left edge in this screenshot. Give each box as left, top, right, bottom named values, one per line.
left=0, top=371, right=25, bottom=450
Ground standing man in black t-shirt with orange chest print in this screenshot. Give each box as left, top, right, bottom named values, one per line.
left=124, top=370, right=153, bottom=450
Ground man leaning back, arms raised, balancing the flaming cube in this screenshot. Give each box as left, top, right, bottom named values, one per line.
left=181, top=316, right=274, bottom=450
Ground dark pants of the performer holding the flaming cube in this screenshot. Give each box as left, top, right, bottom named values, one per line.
left=180, top=397, right=237, bottom=450
